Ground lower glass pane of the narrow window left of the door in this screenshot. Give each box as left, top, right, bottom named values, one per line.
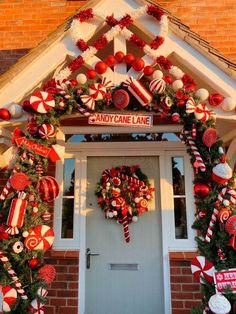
left=61, top=198, right=74, bottom=239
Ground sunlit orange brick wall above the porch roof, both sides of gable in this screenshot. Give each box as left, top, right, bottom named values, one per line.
left=0, top=0, right=236, bottom=74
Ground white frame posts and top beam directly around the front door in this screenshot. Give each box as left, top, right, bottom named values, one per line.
left=66, top=142, right=189, bottom=314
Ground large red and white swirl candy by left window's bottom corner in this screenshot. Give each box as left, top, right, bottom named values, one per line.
left=24, top=225, right=54, bottom=251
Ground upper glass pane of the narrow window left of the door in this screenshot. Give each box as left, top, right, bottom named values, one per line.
left=63, top=158, right=75, bottom=196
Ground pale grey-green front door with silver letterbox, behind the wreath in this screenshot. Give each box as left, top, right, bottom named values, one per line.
left=85, top=156, right=164, bottom=314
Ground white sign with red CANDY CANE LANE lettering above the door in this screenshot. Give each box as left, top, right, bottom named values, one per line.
left=88, top=113, right=153, bottom=128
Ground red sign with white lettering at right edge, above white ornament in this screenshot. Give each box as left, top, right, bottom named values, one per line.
left=214, top=268, right=236, bottom=293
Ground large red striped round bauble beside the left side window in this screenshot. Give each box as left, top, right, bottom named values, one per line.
left=37, top=176, right=59, bottom=202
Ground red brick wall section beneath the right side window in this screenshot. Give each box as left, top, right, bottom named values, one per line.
left=169, top=252, right=202, bottom=314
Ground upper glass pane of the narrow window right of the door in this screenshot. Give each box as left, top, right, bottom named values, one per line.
left=172, top=157, right=185, bottom=195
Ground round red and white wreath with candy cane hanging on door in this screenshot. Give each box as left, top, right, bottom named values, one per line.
left=95, top=165, right=154, bottom=243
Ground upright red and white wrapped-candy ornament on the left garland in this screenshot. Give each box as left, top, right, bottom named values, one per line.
left=6, top=192, right=28, bottom=235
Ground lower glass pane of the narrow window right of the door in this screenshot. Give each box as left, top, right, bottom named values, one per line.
left=174, top=197, right=188, bottom=239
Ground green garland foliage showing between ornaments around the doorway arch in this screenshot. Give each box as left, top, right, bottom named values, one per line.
left=0, top=73, right=236, bottom=314
